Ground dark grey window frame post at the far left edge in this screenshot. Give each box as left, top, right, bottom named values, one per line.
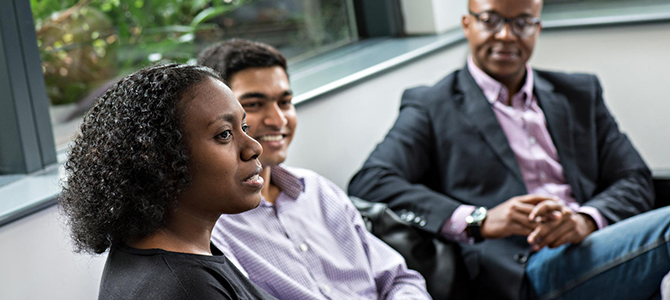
left=0, top=0, right=57, bottom=176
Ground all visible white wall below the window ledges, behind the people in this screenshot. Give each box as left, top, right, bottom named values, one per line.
left=0, top=23, right=670, bottom=300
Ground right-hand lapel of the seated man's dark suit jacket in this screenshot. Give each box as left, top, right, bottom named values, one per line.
left=533, top=72, right=584, bottom=203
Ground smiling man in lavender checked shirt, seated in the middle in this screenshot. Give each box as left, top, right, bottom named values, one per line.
left=198, top=40, right=430, bottom=300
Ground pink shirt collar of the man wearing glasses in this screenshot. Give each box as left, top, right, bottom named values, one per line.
left=468, top=55, right=533, bottom=106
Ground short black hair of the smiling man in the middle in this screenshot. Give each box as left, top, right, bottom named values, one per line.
left=198, top=39, right=288, bottom=84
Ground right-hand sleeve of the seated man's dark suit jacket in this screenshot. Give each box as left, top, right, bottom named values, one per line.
left=577, top=76, right=654, bottom=224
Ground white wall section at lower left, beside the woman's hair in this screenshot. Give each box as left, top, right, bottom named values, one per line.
left=0, top=207, right=105, bottom=300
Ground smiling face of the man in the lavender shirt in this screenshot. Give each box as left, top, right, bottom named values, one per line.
left=230, top=66, right=298, bottom=167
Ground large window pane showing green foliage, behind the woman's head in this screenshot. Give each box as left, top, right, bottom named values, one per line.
left=30, top=0, right=356, bottom=146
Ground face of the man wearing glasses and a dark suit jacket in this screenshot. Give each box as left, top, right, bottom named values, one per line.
left=462, top=0, right=542, bottom=82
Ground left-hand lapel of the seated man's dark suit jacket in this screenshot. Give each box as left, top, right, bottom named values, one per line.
left=459, top=67, right=525, bottom=186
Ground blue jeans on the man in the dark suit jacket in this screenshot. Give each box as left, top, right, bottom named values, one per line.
left=526, top=207, right=670, bottom=300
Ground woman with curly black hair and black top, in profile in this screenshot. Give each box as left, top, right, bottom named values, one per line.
left=60, top=64, right=274, bottom=299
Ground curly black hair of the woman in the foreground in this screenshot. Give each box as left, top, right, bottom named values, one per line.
left=59, top=64, right=222, bottom=253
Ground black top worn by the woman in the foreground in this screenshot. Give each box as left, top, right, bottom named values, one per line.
left=98, top=245, right=275, bottom=300
